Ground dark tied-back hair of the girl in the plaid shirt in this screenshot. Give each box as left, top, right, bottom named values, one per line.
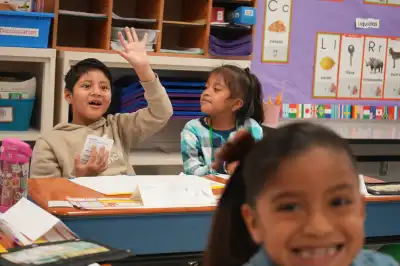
left=211, top=65, right=264, bottom=124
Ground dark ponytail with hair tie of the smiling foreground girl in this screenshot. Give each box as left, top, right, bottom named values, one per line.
left=203, top=133, right=257, bottom=266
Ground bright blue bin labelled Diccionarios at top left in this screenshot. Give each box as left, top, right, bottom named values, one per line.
left=0, top=11, right=54, bottom=48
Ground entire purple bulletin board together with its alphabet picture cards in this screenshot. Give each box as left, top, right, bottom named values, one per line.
left=251, top=0, right=400, bottom=106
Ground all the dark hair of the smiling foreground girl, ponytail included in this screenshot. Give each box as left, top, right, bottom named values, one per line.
left=204, top=122, right=355, bottom=266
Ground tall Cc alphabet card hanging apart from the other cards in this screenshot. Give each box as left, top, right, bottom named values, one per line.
left=261, top=0, right=292, bottom=63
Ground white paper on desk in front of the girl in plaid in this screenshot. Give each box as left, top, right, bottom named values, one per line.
left=138, top=182, right=216, bottom=208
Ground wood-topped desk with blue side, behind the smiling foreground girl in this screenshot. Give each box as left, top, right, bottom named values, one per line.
left=29, top=177, right=400, bottom=255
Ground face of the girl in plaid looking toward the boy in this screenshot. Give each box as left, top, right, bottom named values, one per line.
left=200, top=74, right=242, bottom=116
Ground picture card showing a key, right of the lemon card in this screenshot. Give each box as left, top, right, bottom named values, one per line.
left=337, top=34, right=364, bottom=98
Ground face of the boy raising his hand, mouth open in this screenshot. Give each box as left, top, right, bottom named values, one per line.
left=64, top=70, right=111, bottom=125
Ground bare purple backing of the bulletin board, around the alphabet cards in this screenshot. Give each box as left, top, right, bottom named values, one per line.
left=251, top=0, right=400, bottom=105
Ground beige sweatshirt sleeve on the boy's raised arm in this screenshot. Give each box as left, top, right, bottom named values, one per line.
left=115, top=76, right=172, bottom=150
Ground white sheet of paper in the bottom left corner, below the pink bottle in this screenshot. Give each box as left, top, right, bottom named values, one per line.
left=1, top=198, right=60, bottom=241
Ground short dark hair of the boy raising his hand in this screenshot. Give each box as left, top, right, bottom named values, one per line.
left=64, top=58, right=112, bottom=93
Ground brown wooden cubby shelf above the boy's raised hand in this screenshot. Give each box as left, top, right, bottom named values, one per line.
left=45, top=0, right=257, bottom=60
